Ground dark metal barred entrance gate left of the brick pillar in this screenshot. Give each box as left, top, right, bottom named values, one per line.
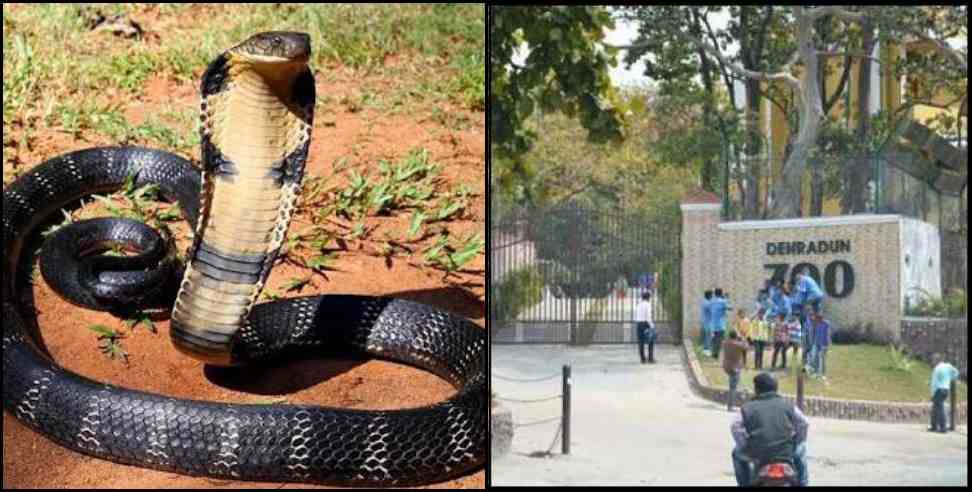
left=489, top=204, right=681, bottom=344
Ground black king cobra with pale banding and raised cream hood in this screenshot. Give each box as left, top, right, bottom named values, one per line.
left=2, top=32, right=487, bottom=486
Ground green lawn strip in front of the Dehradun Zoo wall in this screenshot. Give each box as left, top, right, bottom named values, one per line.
left=693, top=345, right=968, bottom=403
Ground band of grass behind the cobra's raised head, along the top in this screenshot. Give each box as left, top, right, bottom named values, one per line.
left=3, top=4, right=486, bottom=171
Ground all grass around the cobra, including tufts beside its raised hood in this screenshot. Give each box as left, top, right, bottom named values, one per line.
left=3, top=4, right=486, bottom=280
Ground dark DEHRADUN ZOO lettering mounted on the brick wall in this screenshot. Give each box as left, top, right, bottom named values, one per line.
left=763, top=239, right=854, bottom=298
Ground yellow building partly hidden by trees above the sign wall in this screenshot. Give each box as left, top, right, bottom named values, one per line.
left=744, top=41, right=967, bottom=215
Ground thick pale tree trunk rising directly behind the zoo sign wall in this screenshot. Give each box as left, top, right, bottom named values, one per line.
left=769, top=11, right=824, bottom=219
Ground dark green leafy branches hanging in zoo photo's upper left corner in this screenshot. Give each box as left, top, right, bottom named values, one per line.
left=489, top=6, right=623, bottom=206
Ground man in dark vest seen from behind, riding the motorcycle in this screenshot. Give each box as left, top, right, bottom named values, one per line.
left=731, top=373, right=809, bottom=487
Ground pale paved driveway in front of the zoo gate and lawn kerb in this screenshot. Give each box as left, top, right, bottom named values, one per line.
left=491, top=345, right=968, bottom=485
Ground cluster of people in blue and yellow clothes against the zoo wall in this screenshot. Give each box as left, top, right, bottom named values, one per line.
left=701, top=271, right=832, bottom=381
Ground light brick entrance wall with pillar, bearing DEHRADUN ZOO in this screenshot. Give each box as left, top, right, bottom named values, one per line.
left=682, top=194, right=941, bottom=341
